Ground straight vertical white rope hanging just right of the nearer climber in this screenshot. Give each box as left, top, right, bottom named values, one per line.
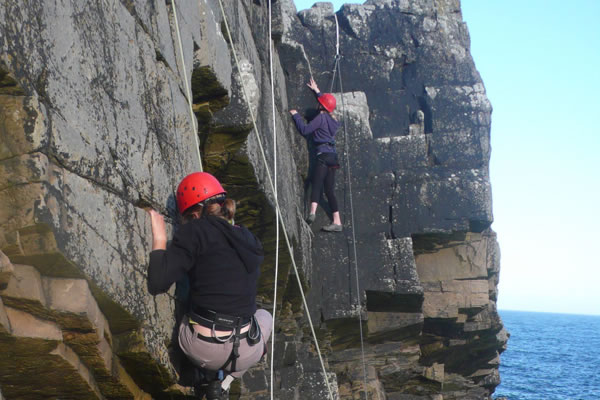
left=267, top=0, right=279, bottom=400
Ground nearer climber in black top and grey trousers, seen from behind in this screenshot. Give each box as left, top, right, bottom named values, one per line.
left=148, top=172, right=272, bottom=399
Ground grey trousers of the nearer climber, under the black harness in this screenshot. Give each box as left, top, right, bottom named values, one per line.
left=179, top=310, right=273, bottom=378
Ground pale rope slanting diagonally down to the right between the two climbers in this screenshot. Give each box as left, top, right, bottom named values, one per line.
left=219, top=0, right=334, bottom=400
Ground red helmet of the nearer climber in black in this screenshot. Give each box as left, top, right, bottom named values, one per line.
left=177, top=172, right=227, bottom=214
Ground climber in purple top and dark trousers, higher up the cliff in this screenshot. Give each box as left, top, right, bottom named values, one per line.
left=290, top=78, right=342, bottom=232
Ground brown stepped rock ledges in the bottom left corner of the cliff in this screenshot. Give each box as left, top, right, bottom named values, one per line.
left=0, top=252, right=156, bottom=399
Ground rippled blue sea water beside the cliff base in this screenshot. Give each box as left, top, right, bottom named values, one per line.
left=493, top=310, right=600, bottom=400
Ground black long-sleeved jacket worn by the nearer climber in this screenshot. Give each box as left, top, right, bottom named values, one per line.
left=148, top=216, right=264, bottom=317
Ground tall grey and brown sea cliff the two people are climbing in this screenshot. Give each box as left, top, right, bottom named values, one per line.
left=0, top=0, right=507, bottom=400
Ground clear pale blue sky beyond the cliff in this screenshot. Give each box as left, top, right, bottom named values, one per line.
left=295, top=0, right=600, bottom=315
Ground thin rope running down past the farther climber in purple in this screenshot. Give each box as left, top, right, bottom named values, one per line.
left=331, top=13, right=372, bottom=400
